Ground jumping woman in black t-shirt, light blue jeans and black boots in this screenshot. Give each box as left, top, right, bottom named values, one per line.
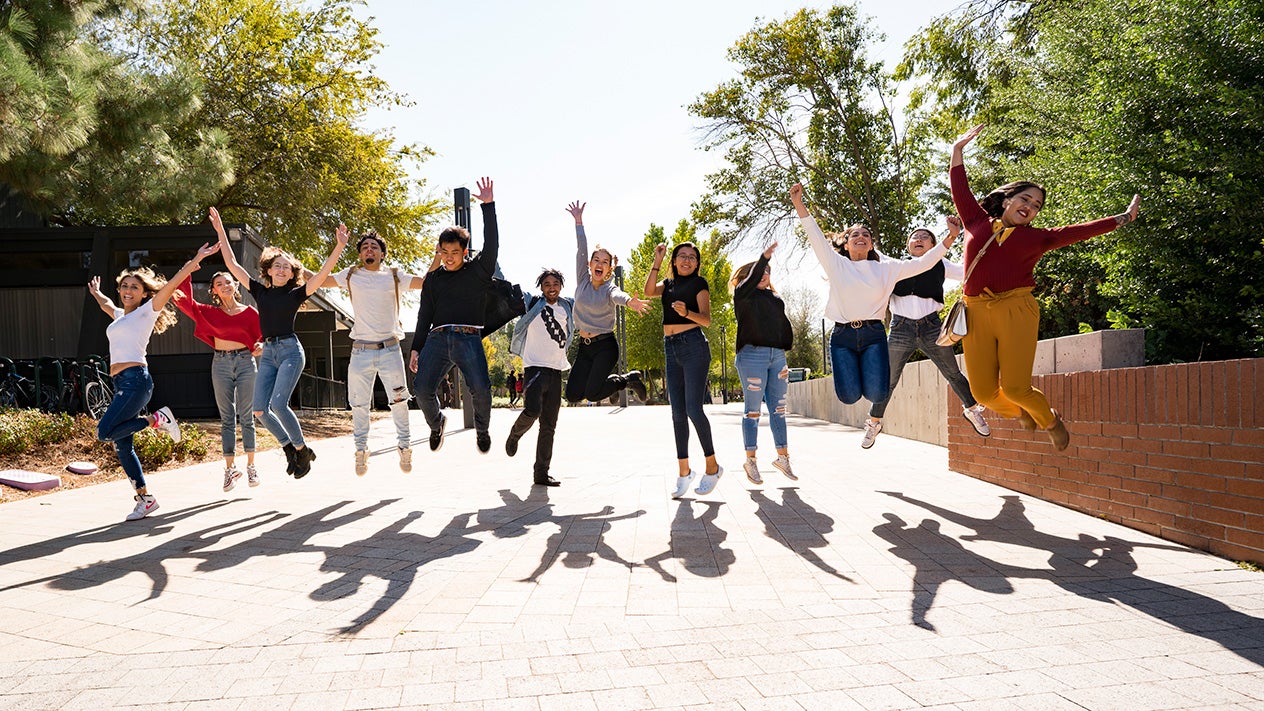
left=210, top=207, right=348, bottom=479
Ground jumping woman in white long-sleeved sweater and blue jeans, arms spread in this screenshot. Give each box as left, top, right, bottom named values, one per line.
left=790, top=183, right=954, bottom=449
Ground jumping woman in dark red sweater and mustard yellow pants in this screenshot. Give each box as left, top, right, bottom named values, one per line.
left=948, top=125, right=1141, bottom=450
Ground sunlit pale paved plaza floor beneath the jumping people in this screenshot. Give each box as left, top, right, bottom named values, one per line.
left=0, top=405, right=1264, bottom=710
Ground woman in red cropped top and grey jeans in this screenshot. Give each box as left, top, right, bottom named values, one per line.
left=172, top=265, right=263, bottom=491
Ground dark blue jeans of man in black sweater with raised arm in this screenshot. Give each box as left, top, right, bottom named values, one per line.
left=412, top=330, right=492, bottom=433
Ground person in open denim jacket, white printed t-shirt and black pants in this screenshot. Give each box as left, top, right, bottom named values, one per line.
left=504, top=269, right=575, bottom=486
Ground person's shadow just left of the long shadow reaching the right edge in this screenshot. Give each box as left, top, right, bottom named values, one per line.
left=873, top=514, right=1014, bottom=631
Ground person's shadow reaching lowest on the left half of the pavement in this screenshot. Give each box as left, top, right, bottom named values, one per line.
left=308, top=511, right=483, bottom=635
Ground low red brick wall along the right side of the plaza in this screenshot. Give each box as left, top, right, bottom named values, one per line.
left=944, top=359, right=1264, bottom=563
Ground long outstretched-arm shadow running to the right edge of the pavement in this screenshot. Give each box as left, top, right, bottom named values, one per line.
left=882, top=492, right=1264, bottom=665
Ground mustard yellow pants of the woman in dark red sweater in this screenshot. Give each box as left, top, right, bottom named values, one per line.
left=962, top=287, right=1054, bottom=429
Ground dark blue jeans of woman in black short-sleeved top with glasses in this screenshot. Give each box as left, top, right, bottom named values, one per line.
left=662, top=328, right=715, bottom=459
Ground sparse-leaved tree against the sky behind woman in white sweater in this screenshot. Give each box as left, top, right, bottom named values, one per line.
left=689, top=5, right=929, bottom=250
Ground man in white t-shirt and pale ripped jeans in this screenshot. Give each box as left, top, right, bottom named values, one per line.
left=313, top=232, right=434, bottom=477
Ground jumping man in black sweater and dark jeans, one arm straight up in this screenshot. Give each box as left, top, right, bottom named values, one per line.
left=408, top=177, right=501, bottom=454
